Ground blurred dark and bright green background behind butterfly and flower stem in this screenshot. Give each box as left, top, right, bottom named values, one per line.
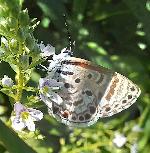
left=0, top=0, right=150, bottom=153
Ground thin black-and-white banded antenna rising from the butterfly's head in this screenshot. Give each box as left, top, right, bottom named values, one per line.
left=63, top=14, right=74, bottom=54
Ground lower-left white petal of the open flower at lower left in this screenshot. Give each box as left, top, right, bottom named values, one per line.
left=11, top=116, right=26, bottom=131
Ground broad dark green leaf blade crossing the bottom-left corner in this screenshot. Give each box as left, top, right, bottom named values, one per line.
left=0, top=120, right=36, bottom=153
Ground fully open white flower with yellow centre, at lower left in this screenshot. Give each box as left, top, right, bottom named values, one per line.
left=11, top=102, right=43, bottom=131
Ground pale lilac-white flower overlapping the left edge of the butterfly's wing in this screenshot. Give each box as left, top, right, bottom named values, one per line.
left=39, top=78, right=64, bottom=107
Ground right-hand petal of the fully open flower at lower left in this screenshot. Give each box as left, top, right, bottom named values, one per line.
left=28, top=108, right=43, bottom=121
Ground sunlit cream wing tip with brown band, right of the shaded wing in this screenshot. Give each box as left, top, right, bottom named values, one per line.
left=99, top=72, right=141, bottom=118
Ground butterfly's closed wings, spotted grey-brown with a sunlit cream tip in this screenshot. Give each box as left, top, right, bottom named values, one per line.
left=49, top=57, right=140, bottom=127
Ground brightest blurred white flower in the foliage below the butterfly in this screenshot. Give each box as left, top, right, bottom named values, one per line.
left=113, top=133, right=127, bottom=148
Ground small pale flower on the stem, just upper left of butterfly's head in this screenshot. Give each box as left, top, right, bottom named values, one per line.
left=38, top=41, right=55, bottom=57
